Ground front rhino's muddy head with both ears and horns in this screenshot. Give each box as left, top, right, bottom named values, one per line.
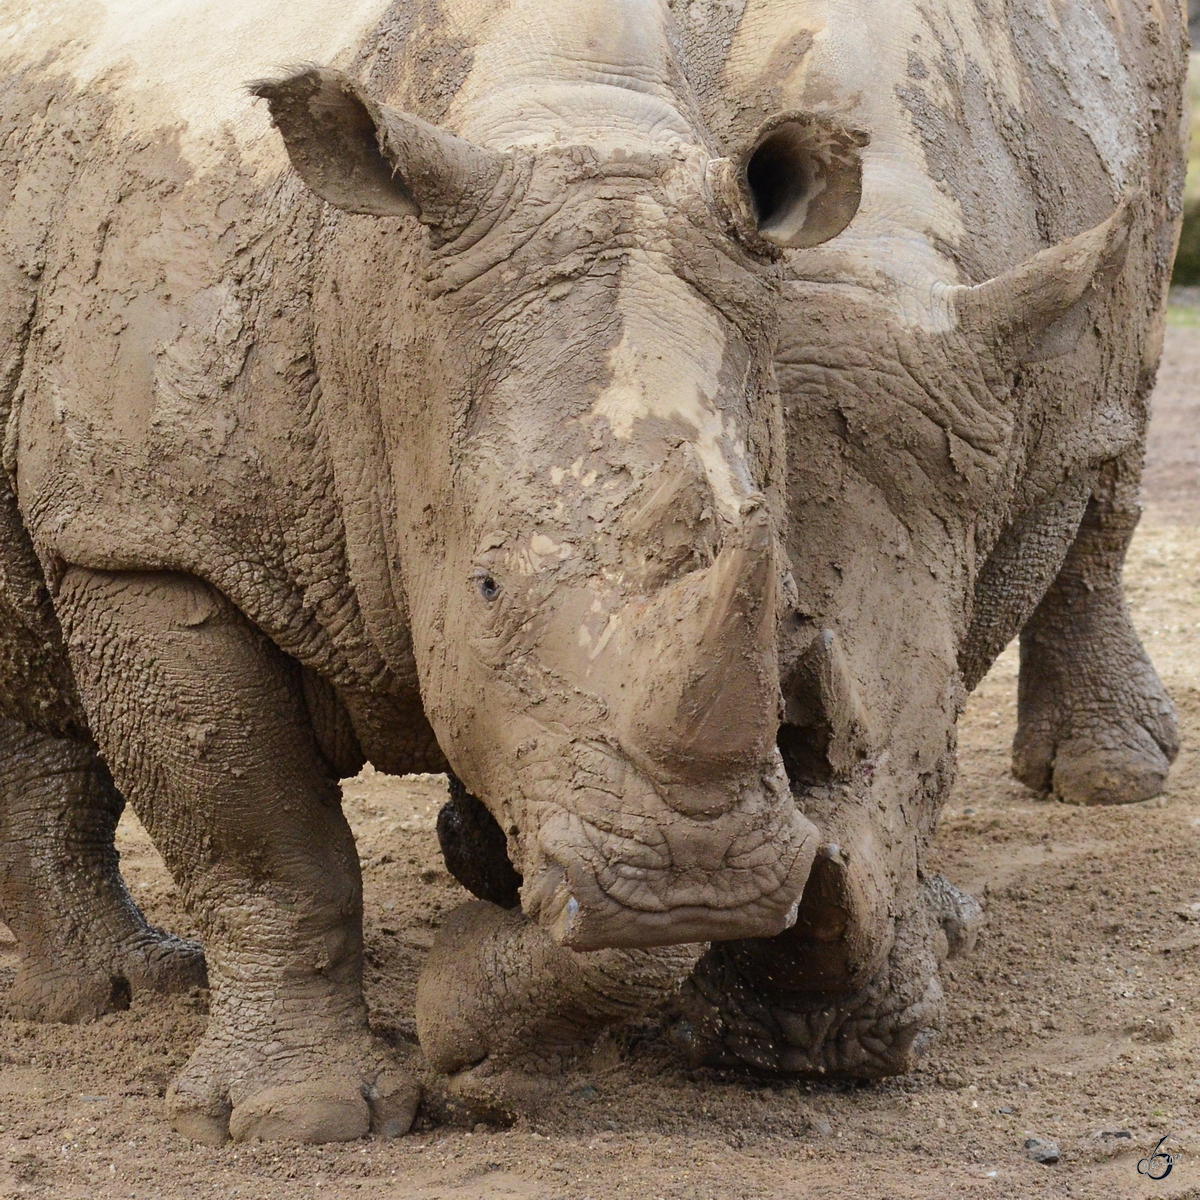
left=259, top=71, right=858, bottom=949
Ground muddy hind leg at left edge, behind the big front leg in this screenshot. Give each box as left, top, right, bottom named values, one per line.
left=0, top=718, right=205, bottom=1021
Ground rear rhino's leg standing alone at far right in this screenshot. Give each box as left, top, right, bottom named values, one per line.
left=1013, top=462, right=1180, bottom=804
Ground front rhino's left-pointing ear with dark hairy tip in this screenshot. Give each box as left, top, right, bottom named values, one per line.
left=250, top=66, right=504, bottom=226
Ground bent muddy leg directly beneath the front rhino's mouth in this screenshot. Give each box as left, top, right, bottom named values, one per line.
left=416, top=900, right=704, bottom=1120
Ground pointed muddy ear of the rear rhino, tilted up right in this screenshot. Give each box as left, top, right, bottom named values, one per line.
left=949, top=193, right=1138, bottom=362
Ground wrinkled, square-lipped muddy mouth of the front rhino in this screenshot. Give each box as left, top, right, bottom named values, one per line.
left=511, top=748, right=820, bottom=950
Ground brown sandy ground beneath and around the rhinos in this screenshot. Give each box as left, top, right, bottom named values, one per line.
left=0, top=319, right=1200, bottom=1200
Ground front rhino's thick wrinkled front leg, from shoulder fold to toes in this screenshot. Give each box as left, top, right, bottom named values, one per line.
left=58, top=568, right=416, bottom=1144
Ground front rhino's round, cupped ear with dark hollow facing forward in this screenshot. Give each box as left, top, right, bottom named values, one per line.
left=710, top=113, right=870, bottom=250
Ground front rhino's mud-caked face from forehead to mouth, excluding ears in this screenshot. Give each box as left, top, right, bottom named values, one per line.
left=424, top=157, right=814, bottom=948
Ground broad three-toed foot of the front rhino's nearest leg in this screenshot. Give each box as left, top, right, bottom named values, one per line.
left=167, top=1012, right=420, bottom=1146
